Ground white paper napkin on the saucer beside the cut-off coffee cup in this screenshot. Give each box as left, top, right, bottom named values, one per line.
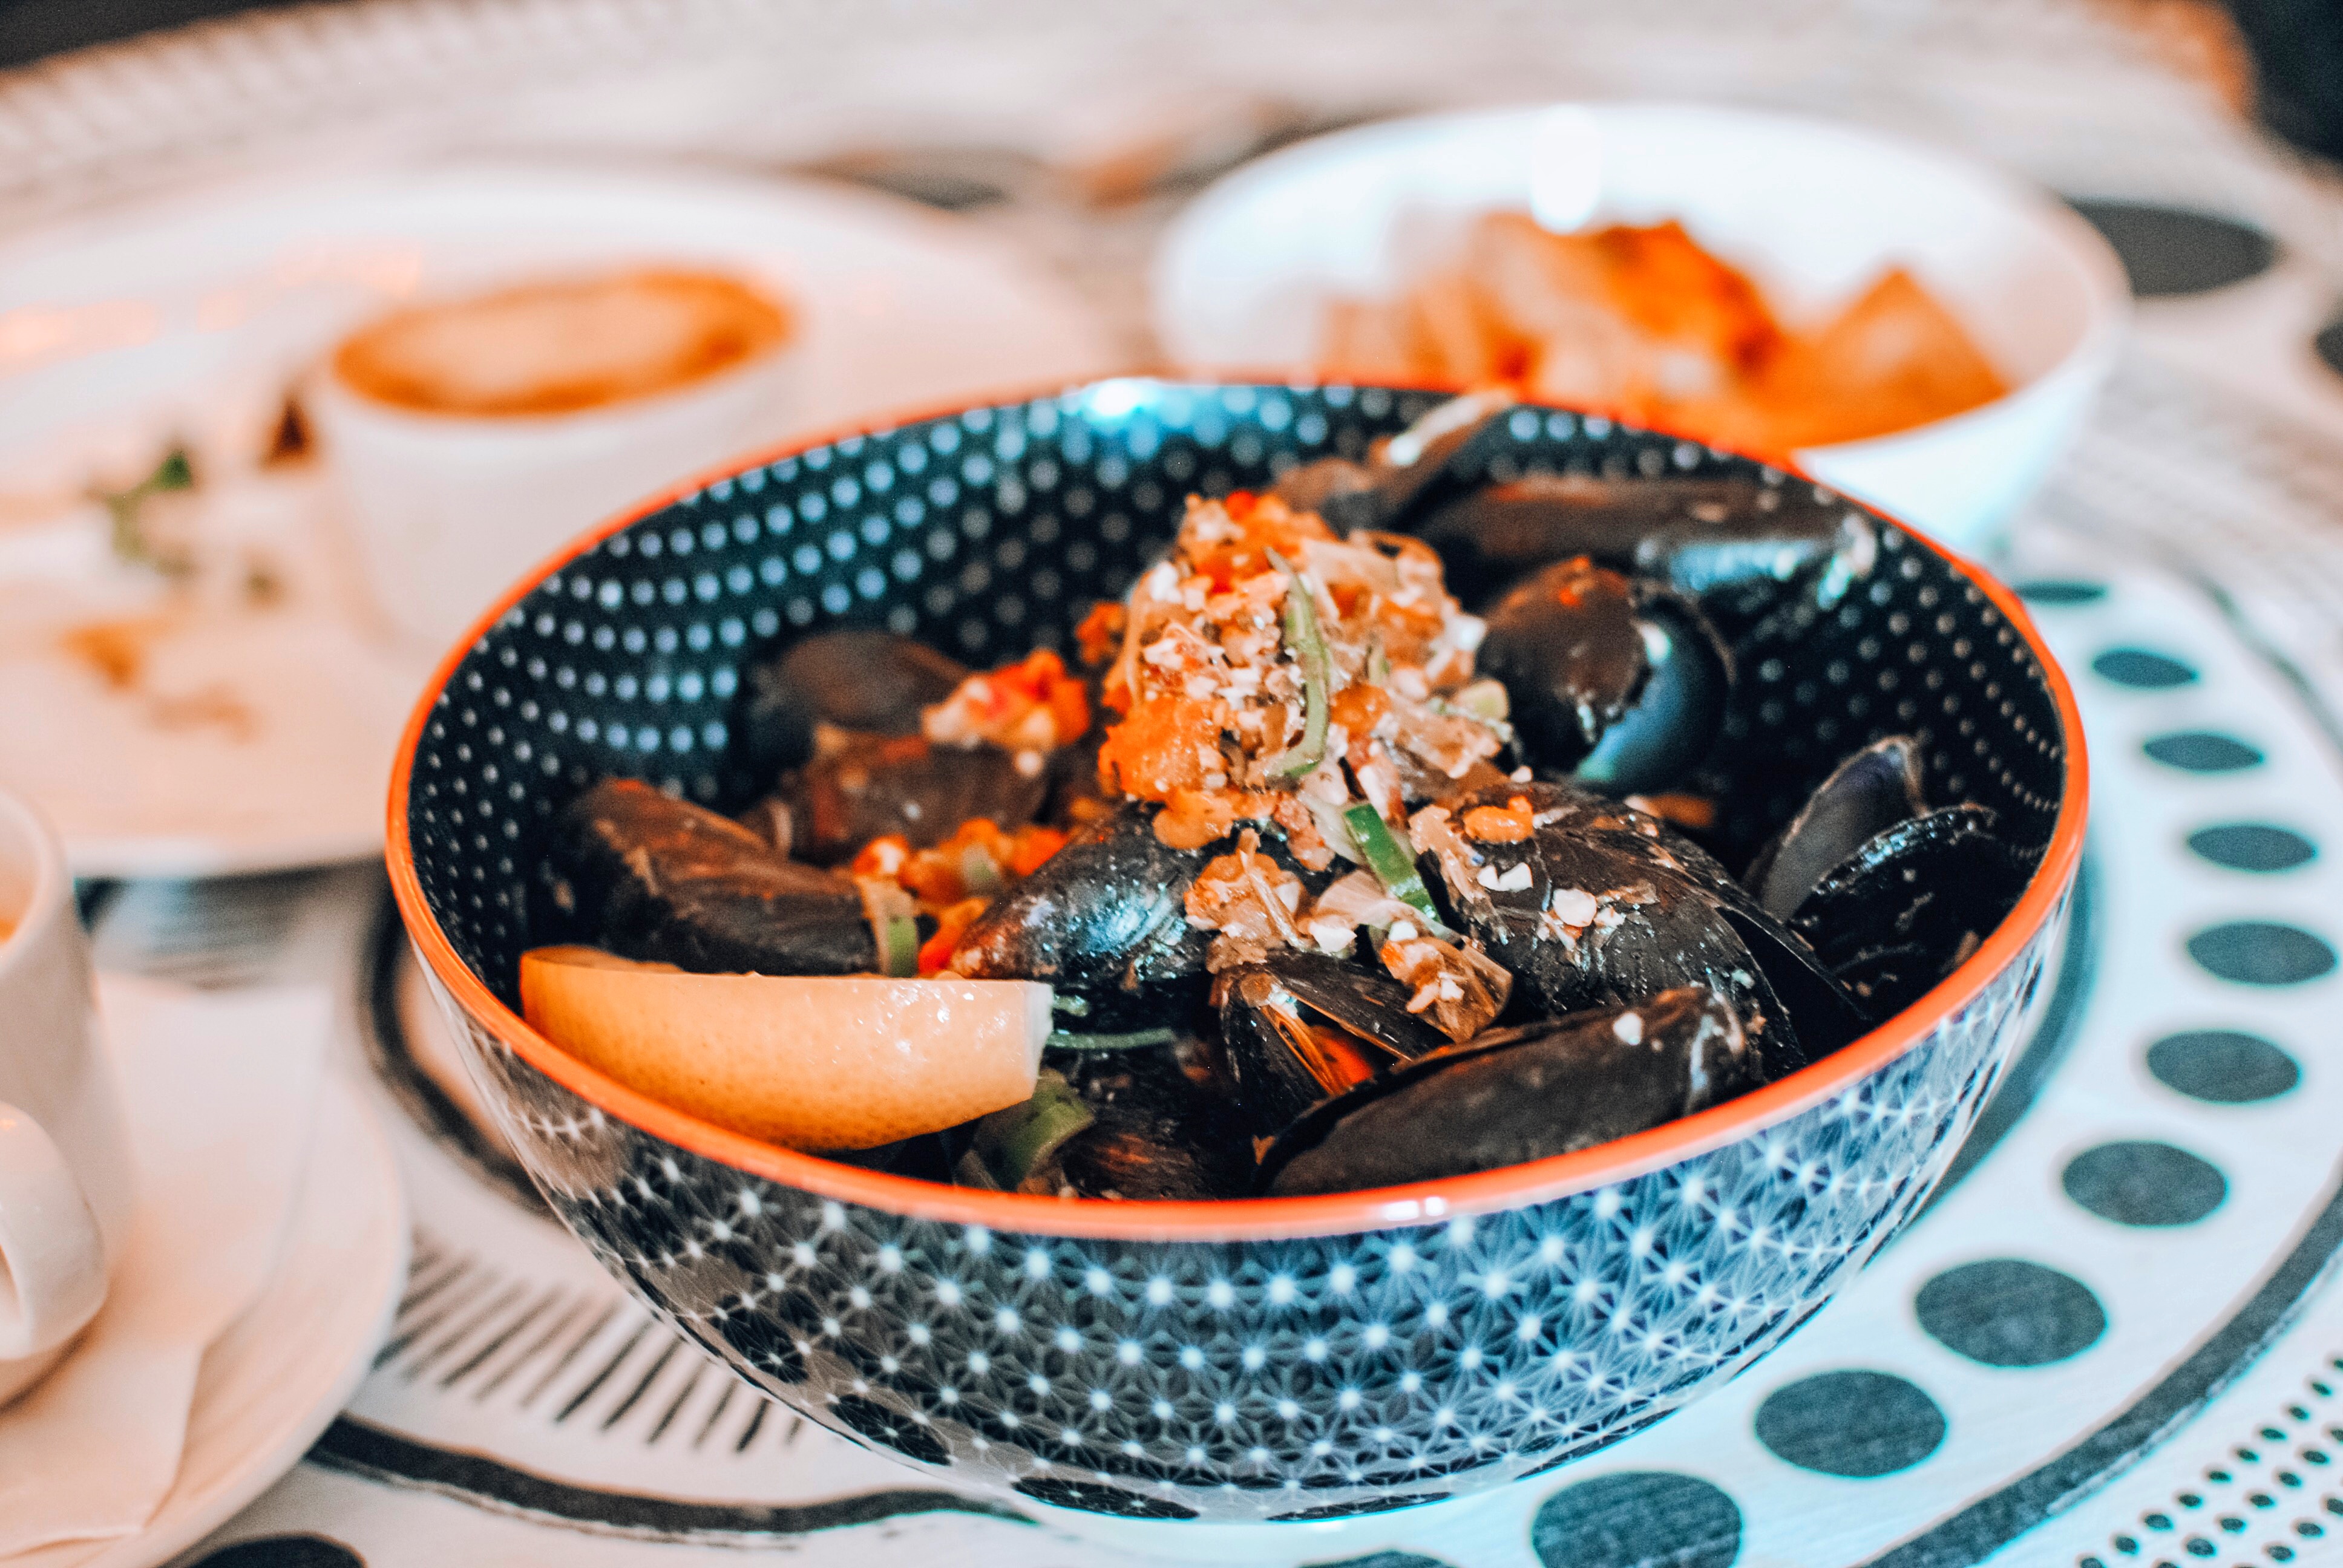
left=0, top=975, right=333, bottom=1563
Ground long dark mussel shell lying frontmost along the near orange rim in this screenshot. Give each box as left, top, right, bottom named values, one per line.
left=1260, top=987, right=1762, bottom=1198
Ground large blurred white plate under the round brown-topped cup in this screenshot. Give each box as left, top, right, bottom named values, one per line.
left=0, top=166, right=1115, bottom=877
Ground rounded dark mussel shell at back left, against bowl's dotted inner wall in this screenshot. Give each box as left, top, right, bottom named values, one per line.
left=733, top=630, right=968, bottom=778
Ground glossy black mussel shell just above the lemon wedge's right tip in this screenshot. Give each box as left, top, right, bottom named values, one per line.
left=951, top=804, right=1214, bottom=1034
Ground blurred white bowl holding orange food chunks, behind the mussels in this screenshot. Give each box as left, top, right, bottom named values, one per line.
left=1153, top=103, right=2130, bottom=549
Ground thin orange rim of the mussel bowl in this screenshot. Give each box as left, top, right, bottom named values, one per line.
left=387, top=373, right=2090, bottom=1242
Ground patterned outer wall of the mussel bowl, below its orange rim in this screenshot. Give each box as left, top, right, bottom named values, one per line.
left=433, top=928, right=2053, bottom=1519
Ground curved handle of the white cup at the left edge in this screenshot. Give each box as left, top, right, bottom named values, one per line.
left=0, top=1102, right=105, bottom=1362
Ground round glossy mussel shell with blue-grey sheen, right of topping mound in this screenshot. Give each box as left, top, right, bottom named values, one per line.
left=1476, top=558, right=1731, bottom=794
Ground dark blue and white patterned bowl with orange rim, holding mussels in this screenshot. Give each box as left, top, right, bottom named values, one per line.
left=389, top=380, right=2085, bottom=1521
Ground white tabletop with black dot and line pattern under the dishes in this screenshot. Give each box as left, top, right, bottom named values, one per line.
left=13, top=0, right=2343, bottom=1568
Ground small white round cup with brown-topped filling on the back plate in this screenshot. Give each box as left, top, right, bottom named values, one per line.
left=302, top=269, right=804, bottom=652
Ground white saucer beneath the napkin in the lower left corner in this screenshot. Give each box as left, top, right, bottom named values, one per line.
left=21, top=1064, right=408, bottom=1568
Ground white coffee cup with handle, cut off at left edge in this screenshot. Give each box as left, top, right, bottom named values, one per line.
left=0, top=794, right=134, bottom=1404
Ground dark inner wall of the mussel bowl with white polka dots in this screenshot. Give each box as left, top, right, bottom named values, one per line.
left=408, top=380, right=2062, bottom=1005
